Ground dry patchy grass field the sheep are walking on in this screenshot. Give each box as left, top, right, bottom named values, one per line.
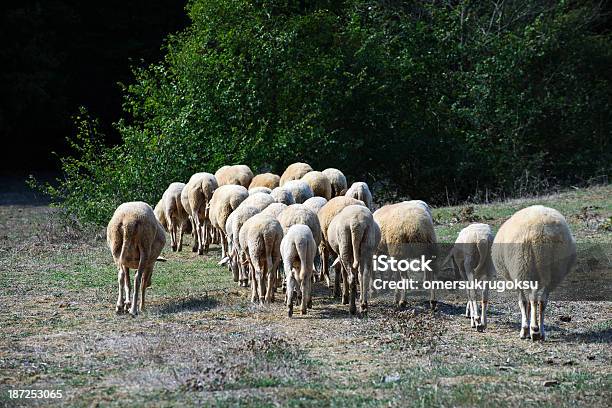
left=0, top=186, right=612, bottom=407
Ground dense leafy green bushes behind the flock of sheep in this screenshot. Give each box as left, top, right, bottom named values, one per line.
left=40, top=0, right=612, bottom=223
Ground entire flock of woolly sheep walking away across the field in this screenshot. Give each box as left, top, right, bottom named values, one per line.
left=107, top=163, right=576, bottom=340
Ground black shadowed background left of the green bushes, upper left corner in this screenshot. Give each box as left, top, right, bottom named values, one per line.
left=0, top=0, right=188, bottom=175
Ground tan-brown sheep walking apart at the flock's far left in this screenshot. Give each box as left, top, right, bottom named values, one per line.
left=106, top=201, right=166, bottom=316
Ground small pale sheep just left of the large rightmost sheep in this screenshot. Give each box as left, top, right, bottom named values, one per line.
left=450, top=223, right=495, bottom=332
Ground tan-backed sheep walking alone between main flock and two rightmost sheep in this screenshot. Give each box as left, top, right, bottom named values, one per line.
left=374, top=201, right=437, bottom=309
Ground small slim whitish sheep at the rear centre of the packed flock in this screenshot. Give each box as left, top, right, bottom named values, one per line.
left=280, top=224, right=317, bottom=317
